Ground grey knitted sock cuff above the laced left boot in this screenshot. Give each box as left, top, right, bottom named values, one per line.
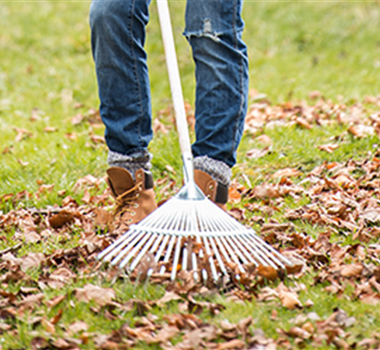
left=107, top=150, right=152, bottom=179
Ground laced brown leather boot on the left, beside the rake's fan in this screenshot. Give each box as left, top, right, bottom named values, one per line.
left=107, top=167, right=157, bottom=232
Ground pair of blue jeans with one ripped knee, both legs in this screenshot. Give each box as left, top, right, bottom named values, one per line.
left=90, top=0, right=248, bottom=167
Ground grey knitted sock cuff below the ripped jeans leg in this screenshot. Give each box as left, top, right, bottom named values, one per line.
left=194, top=156, right=232, bottom=186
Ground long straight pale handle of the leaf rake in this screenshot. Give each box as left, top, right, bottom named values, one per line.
left=156, top=0, right=194, bottom=183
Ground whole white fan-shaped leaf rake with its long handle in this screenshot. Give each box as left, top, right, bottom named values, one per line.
left=98, top=0, right=292, bottom=282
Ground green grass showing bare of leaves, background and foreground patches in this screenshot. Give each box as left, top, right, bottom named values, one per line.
left=0, top=0, right=380, bottom=349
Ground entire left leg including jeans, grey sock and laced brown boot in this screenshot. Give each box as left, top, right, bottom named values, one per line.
left=90, top=0, right=156, bottom=233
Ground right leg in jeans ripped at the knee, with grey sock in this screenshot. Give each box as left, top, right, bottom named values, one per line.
left=184, top=0, right=248, bottom=186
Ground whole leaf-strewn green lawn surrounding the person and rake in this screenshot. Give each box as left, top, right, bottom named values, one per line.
left=0, top=0, right=380, bottom=350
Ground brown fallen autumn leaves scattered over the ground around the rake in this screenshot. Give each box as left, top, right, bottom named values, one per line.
left=0, top=99, right=380, bottom=350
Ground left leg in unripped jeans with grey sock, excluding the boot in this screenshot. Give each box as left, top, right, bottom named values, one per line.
left=90, top=0, right=152, bottom=176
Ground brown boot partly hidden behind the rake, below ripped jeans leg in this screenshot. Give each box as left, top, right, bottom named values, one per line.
left=194, top=170, right=228, bottom=211
